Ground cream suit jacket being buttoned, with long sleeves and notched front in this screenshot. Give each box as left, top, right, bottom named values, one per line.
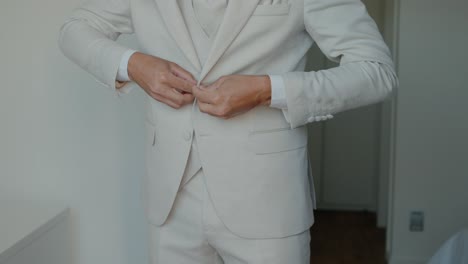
left=59, top=0, right=396, bottom=238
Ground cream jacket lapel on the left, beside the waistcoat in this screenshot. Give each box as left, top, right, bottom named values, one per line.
left=155, top=0, right=201, bottom=71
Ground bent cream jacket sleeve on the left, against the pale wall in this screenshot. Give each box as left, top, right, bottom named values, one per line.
left=59, top=0, right=133, bottom=91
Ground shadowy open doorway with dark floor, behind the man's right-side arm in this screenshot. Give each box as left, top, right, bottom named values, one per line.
left=307, top=0, right=395, bottom=264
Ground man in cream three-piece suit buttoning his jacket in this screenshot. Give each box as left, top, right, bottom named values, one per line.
left=59, top=0, right=397, bottom=264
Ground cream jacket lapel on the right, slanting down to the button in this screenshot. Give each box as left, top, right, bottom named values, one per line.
left=199, top=0, right=260, bottom=82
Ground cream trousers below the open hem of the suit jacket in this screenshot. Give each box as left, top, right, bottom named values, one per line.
left=149, top=170, right=310, bottom=264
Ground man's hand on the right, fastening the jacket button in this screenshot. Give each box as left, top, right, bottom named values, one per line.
left=192, top=75, right=271, bottom=119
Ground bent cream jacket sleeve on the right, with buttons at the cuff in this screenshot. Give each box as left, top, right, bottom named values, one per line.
left=282, top=0, right=398, bottom=128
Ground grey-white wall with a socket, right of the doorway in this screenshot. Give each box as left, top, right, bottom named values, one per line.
left=391, top=0, right=468, bottom=264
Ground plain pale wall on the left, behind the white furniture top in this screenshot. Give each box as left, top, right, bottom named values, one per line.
left=0, top=0, right=148, bottom=264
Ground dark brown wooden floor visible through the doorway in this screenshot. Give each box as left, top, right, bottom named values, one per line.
left=310, top=211, right=386, bottom=264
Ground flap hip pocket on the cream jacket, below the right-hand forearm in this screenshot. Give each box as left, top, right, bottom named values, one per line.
left=247, top=126, right=307, bottom=155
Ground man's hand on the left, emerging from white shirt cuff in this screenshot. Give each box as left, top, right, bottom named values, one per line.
left=127, top=52, right=197, bottom=109
